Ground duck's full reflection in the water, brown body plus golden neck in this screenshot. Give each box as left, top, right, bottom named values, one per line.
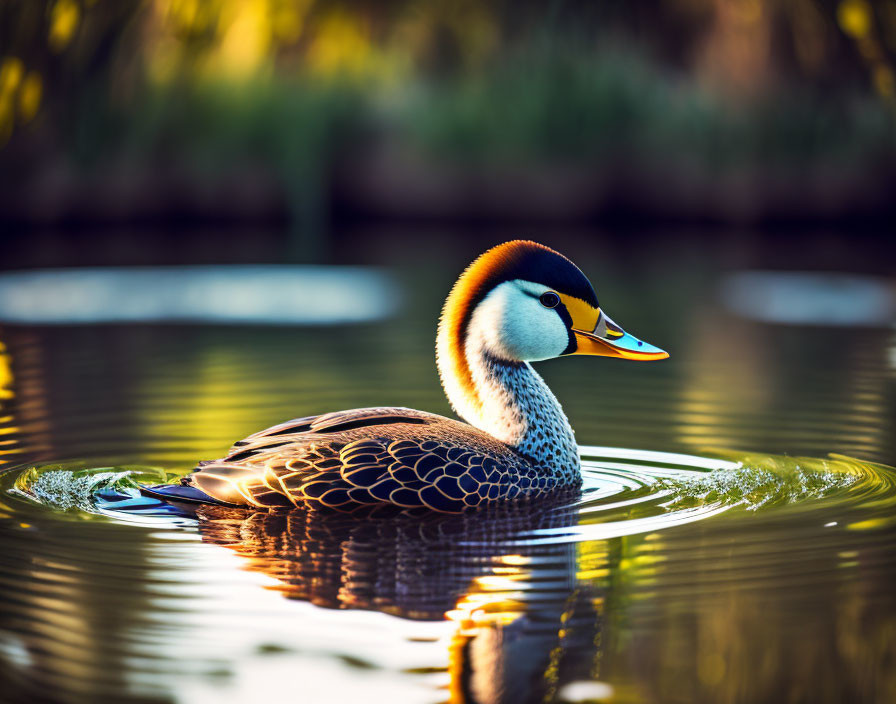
left=197, top=498, right=603, bottom=703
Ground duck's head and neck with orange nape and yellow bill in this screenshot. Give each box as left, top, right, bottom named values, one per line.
left=436, top=240, right=669, bottom=442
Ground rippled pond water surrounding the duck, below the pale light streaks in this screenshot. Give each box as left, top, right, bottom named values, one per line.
left=0, top=238, right=896, bottom=703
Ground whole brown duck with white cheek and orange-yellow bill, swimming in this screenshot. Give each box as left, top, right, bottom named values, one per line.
left=141, top=240, right=669, bottom=513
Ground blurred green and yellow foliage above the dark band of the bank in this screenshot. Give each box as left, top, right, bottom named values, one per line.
left=0, top=0, right=896, bottom=234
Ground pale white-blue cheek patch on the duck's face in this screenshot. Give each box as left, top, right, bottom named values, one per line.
left=467, top=281, right=569, bottom=362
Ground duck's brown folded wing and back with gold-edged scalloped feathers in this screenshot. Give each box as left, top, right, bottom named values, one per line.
left=183, top=408, right=545, bottom=511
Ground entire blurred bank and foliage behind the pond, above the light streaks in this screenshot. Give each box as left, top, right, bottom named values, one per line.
left=0, top=0, right=896, bottom=273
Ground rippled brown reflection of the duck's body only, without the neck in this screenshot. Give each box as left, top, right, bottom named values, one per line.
left=197, top=499, right=578, bottom=619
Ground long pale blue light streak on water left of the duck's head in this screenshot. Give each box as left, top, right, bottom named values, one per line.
left=0, top=265, right=398, bottom=324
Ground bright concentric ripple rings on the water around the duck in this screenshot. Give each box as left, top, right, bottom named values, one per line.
left=3, top=446, right=896, bottom=542
